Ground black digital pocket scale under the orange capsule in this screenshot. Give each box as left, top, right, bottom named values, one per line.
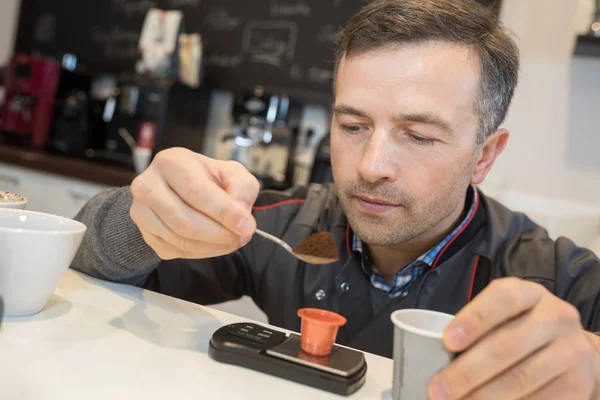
left=208, top=323, right=367, bottom=396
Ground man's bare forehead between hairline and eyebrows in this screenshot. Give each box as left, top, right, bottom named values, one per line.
left=335, top=42, right=480, bottom=107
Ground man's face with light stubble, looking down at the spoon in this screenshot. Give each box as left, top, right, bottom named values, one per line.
left=331, top=42, right=479, bottom=246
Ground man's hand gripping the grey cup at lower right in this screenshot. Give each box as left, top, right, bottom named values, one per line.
left=428, top=278, right=600, bottom=400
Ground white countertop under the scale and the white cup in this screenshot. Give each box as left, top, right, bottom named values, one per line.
left=0, top=270, right=392, bottom=400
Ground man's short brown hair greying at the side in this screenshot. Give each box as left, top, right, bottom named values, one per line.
left=336, top=0, right=519, bottom=145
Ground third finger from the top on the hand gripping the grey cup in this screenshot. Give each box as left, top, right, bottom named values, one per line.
left=448, top=337, right=583, bottom=400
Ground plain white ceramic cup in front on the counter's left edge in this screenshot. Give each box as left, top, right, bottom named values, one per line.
left=0, top=208, right=86, bottom=317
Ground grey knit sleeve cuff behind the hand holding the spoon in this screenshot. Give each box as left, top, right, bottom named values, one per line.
left=71, top=187, right=160, bottom=286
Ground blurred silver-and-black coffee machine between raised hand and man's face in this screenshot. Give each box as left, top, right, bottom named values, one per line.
left=219, top=86, right=301, bottom=189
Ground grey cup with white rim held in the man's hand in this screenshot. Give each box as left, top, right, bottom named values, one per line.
left=391, top=309, right=454, bottom=400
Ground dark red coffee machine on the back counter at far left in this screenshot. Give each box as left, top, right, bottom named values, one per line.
left=0, top=54, right=61, bottom=148
